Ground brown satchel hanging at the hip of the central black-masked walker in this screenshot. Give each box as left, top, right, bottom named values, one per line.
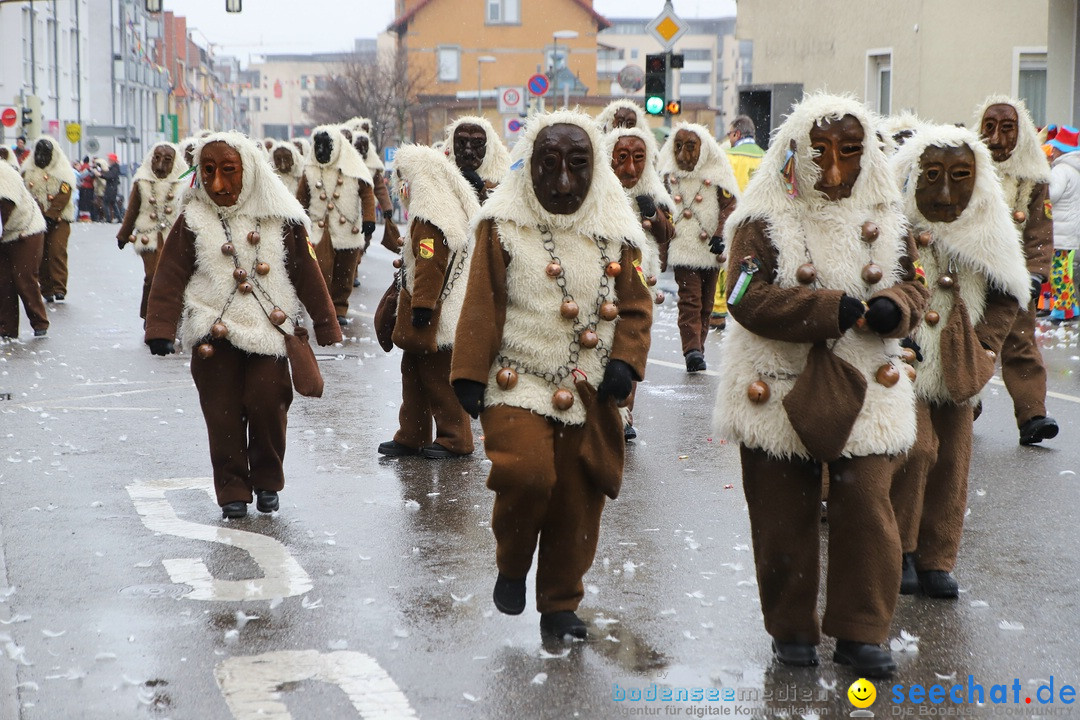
left=573, top=379, right=626, bottom=500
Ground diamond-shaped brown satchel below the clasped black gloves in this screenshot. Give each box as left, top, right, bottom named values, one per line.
left=784, top=342, right=866, bottom=462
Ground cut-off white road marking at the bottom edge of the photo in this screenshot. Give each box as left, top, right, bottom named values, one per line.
left=214, top=650, right=419, bottom=720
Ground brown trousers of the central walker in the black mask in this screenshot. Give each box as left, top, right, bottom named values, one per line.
left=481, top=405, right=605, bottom=613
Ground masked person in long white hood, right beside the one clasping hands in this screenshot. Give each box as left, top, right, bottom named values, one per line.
left=891, top=125, right=1030, bottom=598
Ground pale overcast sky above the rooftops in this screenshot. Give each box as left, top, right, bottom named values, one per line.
left=174, top=0, right=735, bottom=64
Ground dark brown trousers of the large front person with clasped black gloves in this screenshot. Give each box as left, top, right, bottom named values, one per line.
left=741, top=446, right=901, bottom=644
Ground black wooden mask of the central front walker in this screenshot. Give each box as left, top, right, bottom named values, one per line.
left=529, top=123, right=593, bottom=215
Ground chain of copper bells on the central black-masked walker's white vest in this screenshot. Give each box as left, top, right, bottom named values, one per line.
left=495, top=226, right=656, bottom=410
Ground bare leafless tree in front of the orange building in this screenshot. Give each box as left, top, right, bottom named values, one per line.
left=311, top=50, right=428, bottom=147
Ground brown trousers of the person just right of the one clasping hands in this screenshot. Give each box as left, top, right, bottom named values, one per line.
left=890, top=400, right=974, bottom=572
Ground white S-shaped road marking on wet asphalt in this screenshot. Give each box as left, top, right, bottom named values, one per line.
left=127, top=477, right=312, bottom=602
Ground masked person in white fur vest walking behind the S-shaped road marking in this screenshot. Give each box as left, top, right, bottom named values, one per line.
left=146, top=133, right=341, bottom=518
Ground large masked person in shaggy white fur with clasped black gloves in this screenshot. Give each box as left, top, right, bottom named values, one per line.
left=715, top=94, right=927, bottom=677
